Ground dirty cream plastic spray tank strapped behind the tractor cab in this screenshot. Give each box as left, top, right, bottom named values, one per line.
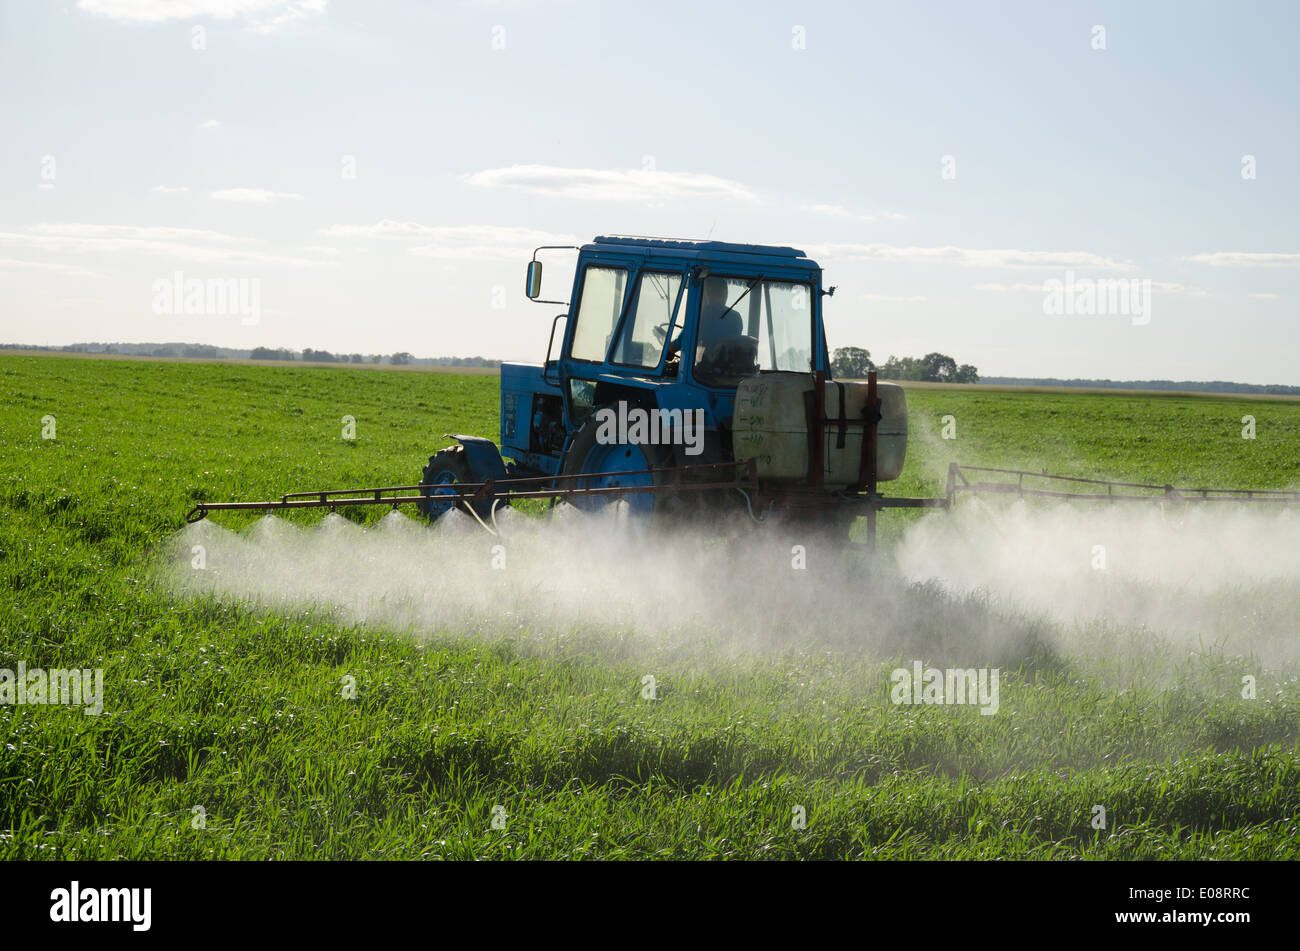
left=732, top=373, right=907, bottom=490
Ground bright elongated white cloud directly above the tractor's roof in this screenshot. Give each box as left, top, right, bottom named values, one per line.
left=462, top=165, right=758, bottom=203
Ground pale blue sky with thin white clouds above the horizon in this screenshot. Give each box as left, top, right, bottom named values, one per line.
left=0, top=0, right=1300, bottom=385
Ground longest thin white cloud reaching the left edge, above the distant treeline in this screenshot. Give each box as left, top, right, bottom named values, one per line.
left=0, top=222, right=324, bottom=268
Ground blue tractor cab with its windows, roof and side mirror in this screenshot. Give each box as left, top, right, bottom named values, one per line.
left=512, top=236, right=827, bottom=472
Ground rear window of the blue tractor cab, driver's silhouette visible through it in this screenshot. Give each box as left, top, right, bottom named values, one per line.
left=696, top=277, right=813, bottom=386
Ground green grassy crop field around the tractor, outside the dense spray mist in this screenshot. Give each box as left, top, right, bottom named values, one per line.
left=0, top=356, right=1300, bottom=859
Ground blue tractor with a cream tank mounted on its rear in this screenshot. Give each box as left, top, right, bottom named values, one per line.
left=420, top=236, right=906, bottom=535
